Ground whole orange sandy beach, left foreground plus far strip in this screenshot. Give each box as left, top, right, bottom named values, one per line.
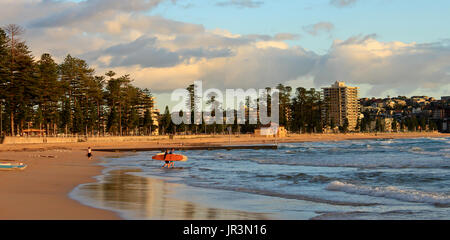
left=0, top=133, right=450, bottom=219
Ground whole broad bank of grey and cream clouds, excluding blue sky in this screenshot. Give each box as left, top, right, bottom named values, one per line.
left=0, top=0, right=450, bottom=96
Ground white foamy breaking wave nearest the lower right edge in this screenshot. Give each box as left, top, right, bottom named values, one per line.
left=326, top=181, right=450, bottom=207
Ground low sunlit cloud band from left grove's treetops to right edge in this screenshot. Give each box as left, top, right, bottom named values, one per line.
left=100, top=35, right=450, bottom=96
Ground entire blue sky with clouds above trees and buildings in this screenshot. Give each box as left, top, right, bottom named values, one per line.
left=0, top=0, right=450, bottom=109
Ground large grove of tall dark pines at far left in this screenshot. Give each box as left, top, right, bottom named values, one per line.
left=0, top=24, right=156, bottom=136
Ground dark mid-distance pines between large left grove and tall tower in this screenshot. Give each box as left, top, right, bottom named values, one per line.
left=156, top=84, right=325, bottom=134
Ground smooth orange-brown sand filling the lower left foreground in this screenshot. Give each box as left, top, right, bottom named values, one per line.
left=0, top=150, right=121, bottom=220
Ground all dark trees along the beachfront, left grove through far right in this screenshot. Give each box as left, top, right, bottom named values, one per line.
left=0, top=25, right=437, bottom=136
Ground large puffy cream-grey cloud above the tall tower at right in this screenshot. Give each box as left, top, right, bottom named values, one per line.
left=313, top=35, right=450, bottom=96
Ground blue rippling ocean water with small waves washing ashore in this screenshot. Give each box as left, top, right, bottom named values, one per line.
left=71, top=138, right=450, bottom=219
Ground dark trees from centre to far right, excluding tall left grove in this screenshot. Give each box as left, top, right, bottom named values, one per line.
left=156, top=81, right=438, bottom=134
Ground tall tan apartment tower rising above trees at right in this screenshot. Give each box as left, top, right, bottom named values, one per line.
left=322, top=82, right=360, bottom=130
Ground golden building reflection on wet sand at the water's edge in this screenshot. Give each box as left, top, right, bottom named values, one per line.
left=79, top=170, right=267, bottom=220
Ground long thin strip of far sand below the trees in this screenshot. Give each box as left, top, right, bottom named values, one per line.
left=0, top=132, right=450, bottom=152
